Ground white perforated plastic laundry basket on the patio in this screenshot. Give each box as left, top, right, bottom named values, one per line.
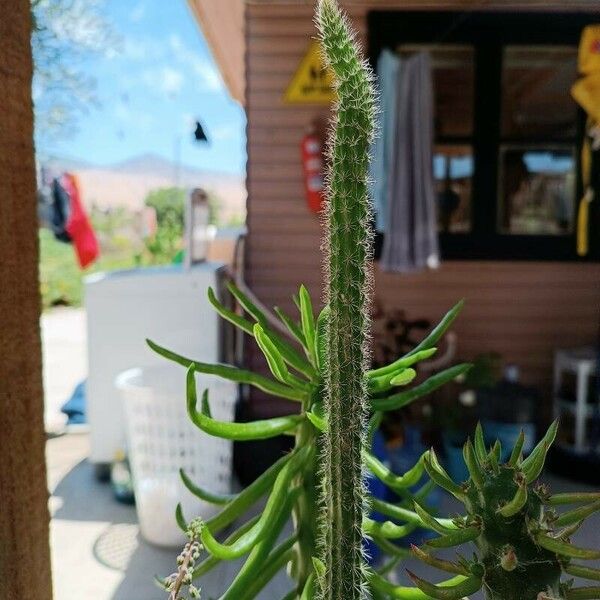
left=115, top=365, right=237, bottom=546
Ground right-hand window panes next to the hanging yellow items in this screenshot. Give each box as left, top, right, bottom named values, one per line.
left=497, top=45, right=577, bottom=235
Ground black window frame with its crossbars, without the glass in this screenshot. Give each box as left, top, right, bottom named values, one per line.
left=367, top=10, right=600, bottom=262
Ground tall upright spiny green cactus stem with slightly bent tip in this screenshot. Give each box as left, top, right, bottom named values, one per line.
left=316, top=0, right=374, bottom=600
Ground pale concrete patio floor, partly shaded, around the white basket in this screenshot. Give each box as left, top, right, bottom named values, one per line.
left=47, top=433, right=600, bottom=600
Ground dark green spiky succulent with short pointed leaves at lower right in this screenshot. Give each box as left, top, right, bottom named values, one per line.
left=392, top=422, right=600, bottom=600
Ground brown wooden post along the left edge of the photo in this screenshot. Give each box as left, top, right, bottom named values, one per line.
left=0, top=0, right=52, bottom=600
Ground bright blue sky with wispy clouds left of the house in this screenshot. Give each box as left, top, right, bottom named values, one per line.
left=39, top=0, right=245, bottom=173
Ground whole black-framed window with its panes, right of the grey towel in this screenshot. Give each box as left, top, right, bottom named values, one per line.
left=368, top=11, right=600, bottom=260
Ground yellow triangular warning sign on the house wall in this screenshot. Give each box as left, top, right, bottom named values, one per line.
left=283, top=40, right=335, bottom=104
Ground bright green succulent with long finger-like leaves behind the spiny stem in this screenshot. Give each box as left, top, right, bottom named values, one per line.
left=148, top=264, right=469, bottom=600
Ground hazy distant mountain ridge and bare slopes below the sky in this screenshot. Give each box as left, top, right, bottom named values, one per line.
left=44, top=154, right=246, bottom=221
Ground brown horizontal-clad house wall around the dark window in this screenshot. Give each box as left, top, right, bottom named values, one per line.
left=246, top=1, right=600, bottom=410
